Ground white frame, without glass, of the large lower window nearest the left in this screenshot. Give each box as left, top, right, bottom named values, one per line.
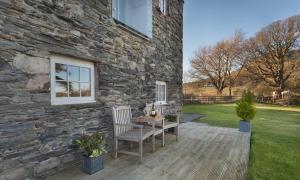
left=50, top=55, right=96, bottom=105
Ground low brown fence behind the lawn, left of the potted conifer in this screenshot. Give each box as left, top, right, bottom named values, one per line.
left=183, top=96, right=241, bottom=104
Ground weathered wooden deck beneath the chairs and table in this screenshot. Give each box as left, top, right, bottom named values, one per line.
left=48, top=122, right=250, bottom=180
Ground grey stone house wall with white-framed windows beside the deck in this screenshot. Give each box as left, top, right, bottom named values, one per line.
left=0, top=0, right=184, bottom=179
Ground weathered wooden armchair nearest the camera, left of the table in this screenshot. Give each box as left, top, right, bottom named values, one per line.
left=112, top=106, right=154, bottom=162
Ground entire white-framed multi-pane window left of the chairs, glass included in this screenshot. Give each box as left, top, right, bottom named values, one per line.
left=51, top=55, right=95, bottom=105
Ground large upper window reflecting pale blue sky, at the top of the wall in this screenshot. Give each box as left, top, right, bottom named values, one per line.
left=112, top=0, right=152, bottom=38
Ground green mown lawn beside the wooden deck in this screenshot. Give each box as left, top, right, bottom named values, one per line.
left=183, top=104, right=300, bottom=180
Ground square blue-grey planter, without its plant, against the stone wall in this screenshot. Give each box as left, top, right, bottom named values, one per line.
left=82, top=156, right=104, bottom=175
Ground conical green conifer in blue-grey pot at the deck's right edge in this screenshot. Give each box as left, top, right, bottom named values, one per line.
left=236, top=90, right=256, bottom=132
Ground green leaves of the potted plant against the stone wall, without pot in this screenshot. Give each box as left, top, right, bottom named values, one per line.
left=75, top=132, right=107, bottom=157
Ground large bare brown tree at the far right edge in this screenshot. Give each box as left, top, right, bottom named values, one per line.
left=245, top=16, right=300, bottom=94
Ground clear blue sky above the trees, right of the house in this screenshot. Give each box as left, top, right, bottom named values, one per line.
left=183, top=0, right=300, bottom=71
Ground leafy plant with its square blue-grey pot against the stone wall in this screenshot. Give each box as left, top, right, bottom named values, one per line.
left=75, top=132, right=107, bottom=174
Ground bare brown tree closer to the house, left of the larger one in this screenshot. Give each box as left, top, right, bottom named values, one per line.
left=191, top=32, right=243, bottom=95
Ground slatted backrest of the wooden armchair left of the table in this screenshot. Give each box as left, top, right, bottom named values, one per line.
left=113, top=106, right=132, bottom=136
